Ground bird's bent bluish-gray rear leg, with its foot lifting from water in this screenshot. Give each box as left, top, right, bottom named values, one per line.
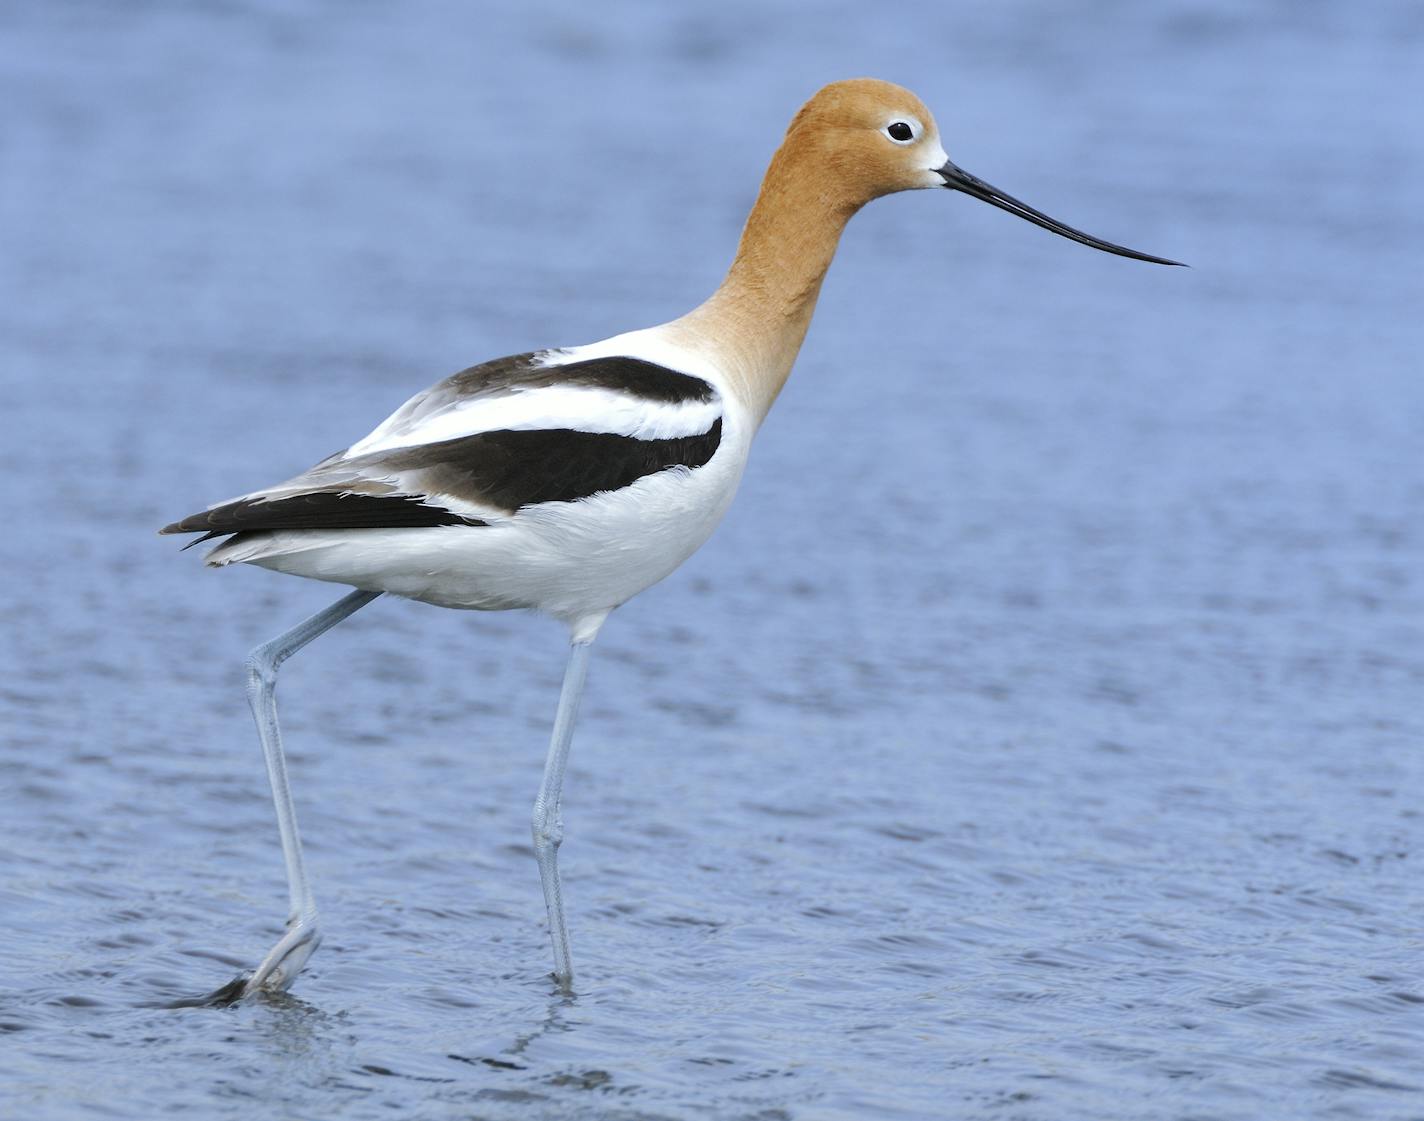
left=242, top=591, right=380, bottom=997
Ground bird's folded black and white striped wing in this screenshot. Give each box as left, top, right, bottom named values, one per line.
left=159, top=350, right=723, bottom=544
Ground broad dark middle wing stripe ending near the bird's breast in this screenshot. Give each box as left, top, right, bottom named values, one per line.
left=380, top=417, right=722, bottom=511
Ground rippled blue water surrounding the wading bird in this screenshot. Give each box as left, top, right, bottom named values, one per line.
left=0, top=0, right=1424, bottom=1121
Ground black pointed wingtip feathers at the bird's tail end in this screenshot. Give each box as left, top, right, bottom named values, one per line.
left=159, top=490, right=488, bottom=544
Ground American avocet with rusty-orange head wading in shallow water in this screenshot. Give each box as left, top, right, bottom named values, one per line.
left=161, top=78, right=1178, bottom=996
